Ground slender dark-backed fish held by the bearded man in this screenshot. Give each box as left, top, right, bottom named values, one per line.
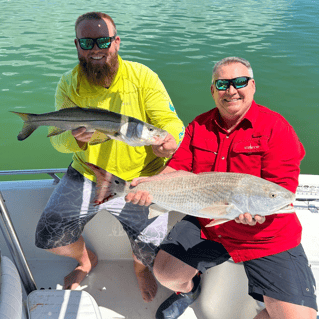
left=13, top=107, right=168, bottom=146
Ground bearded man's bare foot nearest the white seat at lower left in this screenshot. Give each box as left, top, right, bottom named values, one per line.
left=63, top=250, right=98, bottom=290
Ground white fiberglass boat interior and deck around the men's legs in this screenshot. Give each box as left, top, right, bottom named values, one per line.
left=0, top=175, right=319, bottom=319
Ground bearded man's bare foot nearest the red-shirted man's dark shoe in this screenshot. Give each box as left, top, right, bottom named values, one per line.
left=133, top=254, right=157, bottom=302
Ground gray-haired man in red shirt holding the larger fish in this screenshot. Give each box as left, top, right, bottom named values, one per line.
left=126, top=57, right=317, bottom=319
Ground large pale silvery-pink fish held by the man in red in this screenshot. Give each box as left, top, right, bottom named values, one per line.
left=109, top=171, right=295, bottom=226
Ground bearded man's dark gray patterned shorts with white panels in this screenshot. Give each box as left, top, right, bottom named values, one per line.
left=35, top=166, right=168, bottom=267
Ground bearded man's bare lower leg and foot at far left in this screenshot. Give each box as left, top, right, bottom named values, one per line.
left=49, top=236, right=98, bottom=290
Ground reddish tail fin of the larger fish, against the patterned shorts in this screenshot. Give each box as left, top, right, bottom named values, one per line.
left=86, top=163, right=115, bottom=205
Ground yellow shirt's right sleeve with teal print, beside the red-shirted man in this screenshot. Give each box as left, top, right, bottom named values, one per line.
left=144, top=70, right=185, bottom=145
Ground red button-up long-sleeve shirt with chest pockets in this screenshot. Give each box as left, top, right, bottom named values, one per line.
left=168, top=101, right=305, bottom=262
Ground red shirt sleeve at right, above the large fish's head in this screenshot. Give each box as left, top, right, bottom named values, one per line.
left=261, top=123, right=305, bottom=193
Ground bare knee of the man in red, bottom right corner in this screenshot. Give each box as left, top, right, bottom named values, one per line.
left=255, top=296, right=317, bottom=319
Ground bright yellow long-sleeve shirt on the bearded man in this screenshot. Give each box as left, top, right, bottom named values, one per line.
left=49, top=57, right=184, bottom=181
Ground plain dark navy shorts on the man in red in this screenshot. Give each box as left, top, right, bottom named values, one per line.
left=160, top=216, right=318, bottom=311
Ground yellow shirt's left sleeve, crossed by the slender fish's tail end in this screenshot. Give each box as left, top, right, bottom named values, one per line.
left=49, top=76, right=83, bottom=153
